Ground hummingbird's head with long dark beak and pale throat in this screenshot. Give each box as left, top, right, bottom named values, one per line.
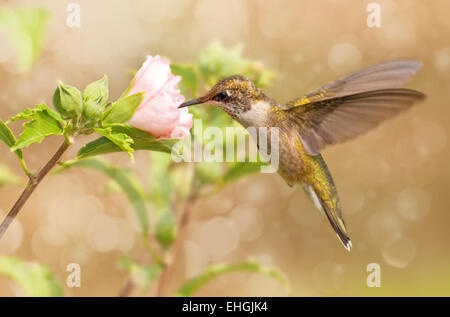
left=179, top=75, right=272, bottom=126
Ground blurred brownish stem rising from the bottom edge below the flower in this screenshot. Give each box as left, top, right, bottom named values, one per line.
left=157, top=190, right=197, bottom=297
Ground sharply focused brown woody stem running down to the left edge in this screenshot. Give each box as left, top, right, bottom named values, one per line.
left=0, top=139, right=70, bottom=239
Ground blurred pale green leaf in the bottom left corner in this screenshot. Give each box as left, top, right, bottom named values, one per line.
left=0, top=256, right=63, bottom=297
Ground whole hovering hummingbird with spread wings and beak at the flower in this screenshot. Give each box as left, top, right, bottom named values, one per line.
left=179, top=60, right=425, bottom=251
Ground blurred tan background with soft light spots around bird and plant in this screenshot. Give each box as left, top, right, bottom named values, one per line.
left=0, top=0, right=450, bottom=296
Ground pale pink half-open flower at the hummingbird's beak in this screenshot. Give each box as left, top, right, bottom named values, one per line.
left=128, top=56, right=192, bottom=139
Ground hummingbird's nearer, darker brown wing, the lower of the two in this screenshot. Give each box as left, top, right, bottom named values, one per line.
left=286, top=88, right=425, bottom=155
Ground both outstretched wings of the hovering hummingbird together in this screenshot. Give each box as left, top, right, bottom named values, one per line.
left=284, top=61, right=425, bottom=155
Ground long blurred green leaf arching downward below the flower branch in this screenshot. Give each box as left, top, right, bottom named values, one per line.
left=62, top=158, right=149, bottom=236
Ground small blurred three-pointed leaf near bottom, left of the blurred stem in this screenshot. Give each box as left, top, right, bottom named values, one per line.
left=119, top=256, right=162, bottom=291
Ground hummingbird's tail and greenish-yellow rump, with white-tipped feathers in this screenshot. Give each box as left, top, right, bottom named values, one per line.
left=302, top=154, right=352, bottom=251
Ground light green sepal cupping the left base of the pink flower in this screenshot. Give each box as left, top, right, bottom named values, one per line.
left=102, top=92, right=144, bottom=125
